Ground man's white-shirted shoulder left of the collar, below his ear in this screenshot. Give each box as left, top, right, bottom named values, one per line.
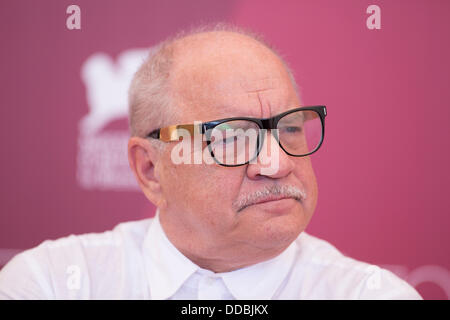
left=0, top=218, right=153, bottom=299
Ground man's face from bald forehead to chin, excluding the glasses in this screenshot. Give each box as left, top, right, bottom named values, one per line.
left=158, top=32, right=317, bottom=268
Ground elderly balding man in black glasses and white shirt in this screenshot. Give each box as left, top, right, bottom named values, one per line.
left=0, top=26, right=420, bottom=299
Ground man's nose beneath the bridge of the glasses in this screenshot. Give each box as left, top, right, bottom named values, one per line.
left=247, top=130, right=295, bottom=180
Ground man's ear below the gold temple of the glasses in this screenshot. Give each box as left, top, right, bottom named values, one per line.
left=128, top=137, right=165, bottom=207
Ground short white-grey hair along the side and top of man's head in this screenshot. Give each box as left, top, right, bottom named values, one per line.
left=129, top=23, right=298, bottom=146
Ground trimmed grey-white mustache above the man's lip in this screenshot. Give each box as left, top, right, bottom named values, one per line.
left=233, top=185, right=306, bottom=212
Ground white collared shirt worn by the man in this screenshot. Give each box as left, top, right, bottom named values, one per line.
left=0, top=213, right=421, bottom=300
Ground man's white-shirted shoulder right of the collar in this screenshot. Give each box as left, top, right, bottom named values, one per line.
left=294, top=232, right=421, bottom=299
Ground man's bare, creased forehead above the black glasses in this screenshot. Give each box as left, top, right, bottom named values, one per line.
left=167, top=31, right=299, bottom=122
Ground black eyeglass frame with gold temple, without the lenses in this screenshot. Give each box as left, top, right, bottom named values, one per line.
left=147, top=106, right=327, bottom=167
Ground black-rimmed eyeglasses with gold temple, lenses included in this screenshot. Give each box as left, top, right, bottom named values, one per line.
left=147, top=106, right=327, bottom=167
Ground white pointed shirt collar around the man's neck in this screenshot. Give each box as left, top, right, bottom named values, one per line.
left=143, top=210, right=296, bottom=300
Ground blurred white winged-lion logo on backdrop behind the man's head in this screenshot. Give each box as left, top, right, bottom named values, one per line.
left=77, top=49, right=149, bottom=190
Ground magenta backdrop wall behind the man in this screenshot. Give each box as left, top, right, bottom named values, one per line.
left=0, top=0, right=450, bottom=299
